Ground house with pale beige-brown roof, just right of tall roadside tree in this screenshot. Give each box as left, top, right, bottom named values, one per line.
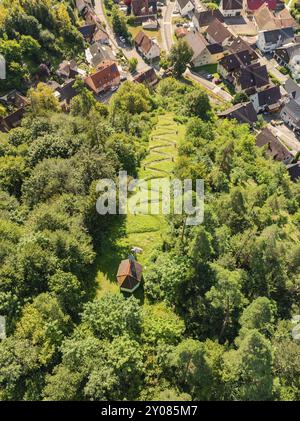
left=184, top=31, right=224, bottom=67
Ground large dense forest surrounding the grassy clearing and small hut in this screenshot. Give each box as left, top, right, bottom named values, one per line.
left=0, top=78, right=300, bottom=400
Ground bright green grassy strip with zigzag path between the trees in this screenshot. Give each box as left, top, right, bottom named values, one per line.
left=96, top=113, right=185, bottom=298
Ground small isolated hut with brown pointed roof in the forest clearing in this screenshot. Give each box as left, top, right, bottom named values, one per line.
left=117, top=257, right=143, bottom=293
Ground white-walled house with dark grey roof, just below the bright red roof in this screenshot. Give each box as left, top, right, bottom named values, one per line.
left=256, top=28, right=294, bottom=53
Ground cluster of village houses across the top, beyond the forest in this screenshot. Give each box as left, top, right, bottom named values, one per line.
left=0, top=0, right=300, bottom=179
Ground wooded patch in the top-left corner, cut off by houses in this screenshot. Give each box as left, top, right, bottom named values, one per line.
left=0, top=0, right=84, bottom=93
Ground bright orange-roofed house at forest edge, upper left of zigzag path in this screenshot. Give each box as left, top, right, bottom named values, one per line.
left=84, top=60, right=120, bottom=95
